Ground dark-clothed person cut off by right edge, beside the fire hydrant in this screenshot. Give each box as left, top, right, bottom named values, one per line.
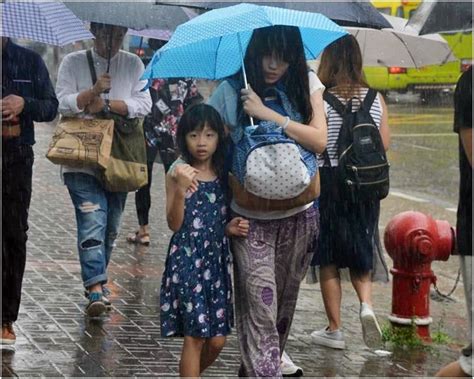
left=436, top=66, right=472, bottom=377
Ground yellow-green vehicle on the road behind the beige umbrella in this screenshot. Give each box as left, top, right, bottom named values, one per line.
left=364, top=0, right=472, bottom=97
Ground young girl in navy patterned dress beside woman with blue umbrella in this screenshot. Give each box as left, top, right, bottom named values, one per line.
left=160, top=104, right=248, bottom=377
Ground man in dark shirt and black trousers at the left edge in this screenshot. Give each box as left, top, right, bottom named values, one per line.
left=0, top=37, right=58, bottom=345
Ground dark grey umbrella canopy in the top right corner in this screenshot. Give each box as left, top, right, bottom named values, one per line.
left=408, top=0, right=472, bottom=34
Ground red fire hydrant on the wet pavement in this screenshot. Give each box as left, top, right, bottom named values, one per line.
left=384, top=211, right=455, bottom=340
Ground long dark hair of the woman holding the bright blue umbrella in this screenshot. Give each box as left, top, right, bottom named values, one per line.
left=239, top=25, right=313, bottom=124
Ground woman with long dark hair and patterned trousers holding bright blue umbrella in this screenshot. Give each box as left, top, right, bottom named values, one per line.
left=209, top=26, right=327, bottom=377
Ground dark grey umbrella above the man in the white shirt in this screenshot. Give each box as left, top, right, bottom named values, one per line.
left=65, top=1, right=196, bottom=30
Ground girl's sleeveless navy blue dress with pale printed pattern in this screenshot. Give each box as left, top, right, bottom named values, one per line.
left=160, top=179, right=233, bottom=338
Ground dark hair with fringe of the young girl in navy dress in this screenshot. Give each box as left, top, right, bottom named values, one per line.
left=176, top=104, right=226, bottom=178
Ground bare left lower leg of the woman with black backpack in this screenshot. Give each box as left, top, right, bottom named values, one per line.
left=319, top=265, right=342, bottom=330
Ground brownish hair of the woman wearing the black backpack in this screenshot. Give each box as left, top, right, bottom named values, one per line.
left=318, top=34, right=368, bottom=99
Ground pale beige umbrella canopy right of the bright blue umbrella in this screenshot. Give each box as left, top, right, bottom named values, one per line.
left=346, top=16, right=457, bottom=68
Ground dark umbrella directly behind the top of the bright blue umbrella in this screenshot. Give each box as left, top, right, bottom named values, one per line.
left=156, top=0, right=392, bottom=29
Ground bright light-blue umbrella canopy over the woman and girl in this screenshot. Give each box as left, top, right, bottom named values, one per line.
left=144, top=3, right=347, bottom=79
